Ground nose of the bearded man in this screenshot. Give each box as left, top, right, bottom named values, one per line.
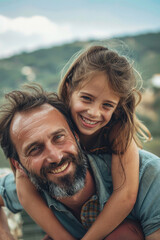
left=45, top=144, right=63, bottom=164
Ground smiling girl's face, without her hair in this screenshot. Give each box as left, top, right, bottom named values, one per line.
left=70, top=73, right=120, bottom=137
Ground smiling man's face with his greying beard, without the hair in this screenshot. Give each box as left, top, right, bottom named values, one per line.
left=10, top=104, right=86, bottom=198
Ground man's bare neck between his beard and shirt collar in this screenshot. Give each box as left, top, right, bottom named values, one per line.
left=59, top=170, right=96, bottom=215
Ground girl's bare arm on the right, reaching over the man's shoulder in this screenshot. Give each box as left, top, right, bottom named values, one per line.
left=82, top=140, right=139, bottom=240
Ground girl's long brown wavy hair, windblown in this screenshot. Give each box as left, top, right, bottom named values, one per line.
left=58, top=46, right=151, bottom=154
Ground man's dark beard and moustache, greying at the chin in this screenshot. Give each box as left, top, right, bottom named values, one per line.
left=24, top=149, right=88, bottom=199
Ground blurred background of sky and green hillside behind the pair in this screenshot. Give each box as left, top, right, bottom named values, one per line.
left=0, top=0, right=160, bottom=240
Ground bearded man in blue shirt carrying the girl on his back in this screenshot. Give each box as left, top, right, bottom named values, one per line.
left=0, top=87, right=160, bottom=240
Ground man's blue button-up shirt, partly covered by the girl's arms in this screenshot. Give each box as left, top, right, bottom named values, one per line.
left=0, top=150, right=160, bottom=238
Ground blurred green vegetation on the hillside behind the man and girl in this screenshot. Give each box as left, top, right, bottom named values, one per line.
left=0, top=33, right=160, bottom=167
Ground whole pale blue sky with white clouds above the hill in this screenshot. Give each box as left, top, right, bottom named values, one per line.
left=0, top=0, right=160, bottom=58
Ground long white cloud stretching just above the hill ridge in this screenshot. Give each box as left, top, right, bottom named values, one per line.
left=0, top=15, right=125, bottom=57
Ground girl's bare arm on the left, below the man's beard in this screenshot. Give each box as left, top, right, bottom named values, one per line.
left=16, top=170, right=75, bottom=240
